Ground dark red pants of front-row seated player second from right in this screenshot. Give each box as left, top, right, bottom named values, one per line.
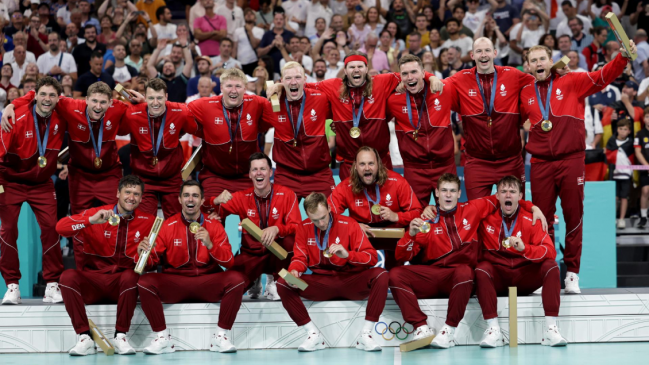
left=390, top=265, right=474, bottom=328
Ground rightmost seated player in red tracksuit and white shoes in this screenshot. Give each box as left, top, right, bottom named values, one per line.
left=475, top=176, right=567, bottom=347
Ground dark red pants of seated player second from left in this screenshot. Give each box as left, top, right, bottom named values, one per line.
left=137, top=270, right=246, bottom=332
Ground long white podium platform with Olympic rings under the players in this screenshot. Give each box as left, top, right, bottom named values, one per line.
left=0, top=288, right=649, bottom=353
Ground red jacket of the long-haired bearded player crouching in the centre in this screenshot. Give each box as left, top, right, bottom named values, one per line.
left=329, top=170, right=422, bottom=227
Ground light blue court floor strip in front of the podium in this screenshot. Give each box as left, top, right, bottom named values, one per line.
left=0, top=342, right=649, bottom=365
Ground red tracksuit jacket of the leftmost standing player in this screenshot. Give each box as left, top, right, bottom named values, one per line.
left=0, top=103, right=67, bottom=184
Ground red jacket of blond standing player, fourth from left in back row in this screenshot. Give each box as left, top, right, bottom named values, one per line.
left=187, top=95, right=267, bottom=176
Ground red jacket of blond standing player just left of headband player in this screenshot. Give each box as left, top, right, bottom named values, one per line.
left=263, top=89, right=331, bottom=175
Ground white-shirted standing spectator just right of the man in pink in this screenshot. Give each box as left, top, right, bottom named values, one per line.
left=233, top=8, right=264, bottom=74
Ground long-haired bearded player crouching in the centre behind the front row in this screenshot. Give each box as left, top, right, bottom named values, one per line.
left=329, top=147, right=422, bottom=270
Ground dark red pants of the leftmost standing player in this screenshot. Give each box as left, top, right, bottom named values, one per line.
left=0, top=179, right=63, bottom=284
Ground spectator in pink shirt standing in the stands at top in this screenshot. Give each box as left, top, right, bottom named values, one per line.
left=194, top=0, right=228, bottom=57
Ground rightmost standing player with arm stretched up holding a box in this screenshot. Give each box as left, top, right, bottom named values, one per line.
left=520, top=41, right=635, bottom=293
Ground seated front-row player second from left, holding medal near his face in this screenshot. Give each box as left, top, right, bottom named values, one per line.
left=136, top=180, right=246, bottom=355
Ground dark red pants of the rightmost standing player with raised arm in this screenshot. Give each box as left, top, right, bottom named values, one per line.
left=530, top=158, right=586, bottom=274
